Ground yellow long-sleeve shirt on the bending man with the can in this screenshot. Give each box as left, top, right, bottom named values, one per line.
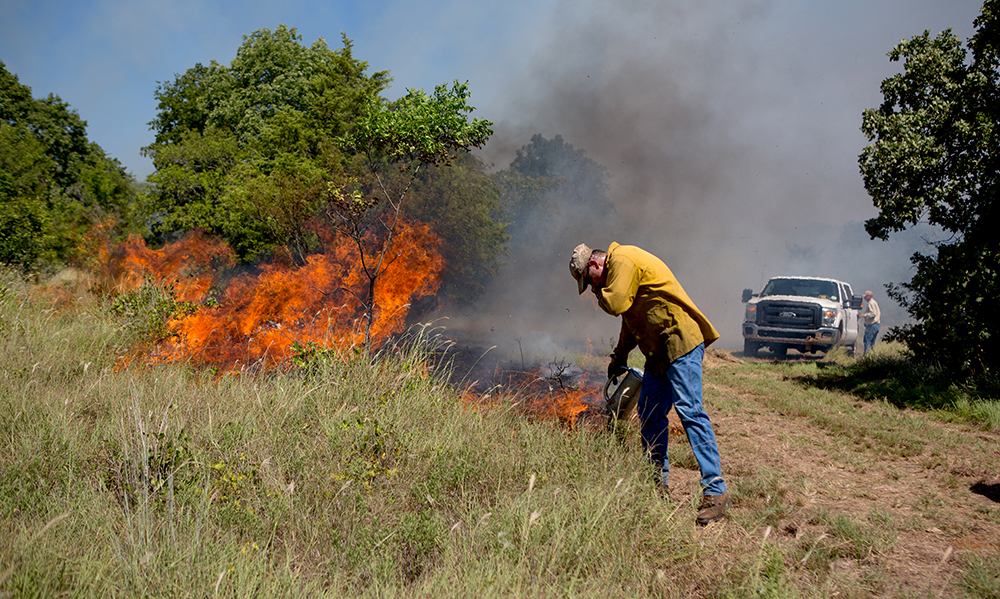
left=598, top=243, right=719, bottom=374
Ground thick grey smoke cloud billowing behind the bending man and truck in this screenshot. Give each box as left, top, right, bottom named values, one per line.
left=434, top=0, right=978, bottom=359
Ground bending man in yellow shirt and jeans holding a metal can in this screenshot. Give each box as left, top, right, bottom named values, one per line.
left=569, top=243, right=732, bottom=524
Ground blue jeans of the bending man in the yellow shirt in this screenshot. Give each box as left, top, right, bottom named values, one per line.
left=638, top=344, right=726, bottom=495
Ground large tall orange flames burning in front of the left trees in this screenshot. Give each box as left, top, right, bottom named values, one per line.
left=106, top=224, right=444, bottom=370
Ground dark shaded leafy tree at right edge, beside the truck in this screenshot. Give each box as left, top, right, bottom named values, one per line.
left=859, top=0, right=1000, bottom=379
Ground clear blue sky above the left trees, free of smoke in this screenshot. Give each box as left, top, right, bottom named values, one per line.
left=0, top=0, right=543, bottom=179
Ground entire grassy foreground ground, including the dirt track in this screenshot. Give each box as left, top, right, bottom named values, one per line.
left=0, top=279, right=1000, bottom=597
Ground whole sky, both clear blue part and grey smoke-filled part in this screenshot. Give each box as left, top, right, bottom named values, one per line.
left=0, top=0, right=981, bottom=350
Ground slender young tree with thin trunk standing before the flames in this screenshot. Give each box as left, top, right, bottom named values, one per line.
left=329, top=81, right=493, bottom=348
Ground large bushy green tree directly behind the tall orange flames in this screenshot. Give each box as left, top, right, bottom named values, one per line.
left=144, top=25, right=390, bottom=261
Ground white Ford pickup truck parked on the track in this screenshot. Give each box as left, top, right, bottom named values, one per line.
left=743, top=277, right=861, bottom=358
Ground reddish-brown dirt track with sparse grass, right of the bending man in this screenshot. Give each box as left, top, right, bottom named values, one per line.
left=652, top=352, right=1000, bottom=597
